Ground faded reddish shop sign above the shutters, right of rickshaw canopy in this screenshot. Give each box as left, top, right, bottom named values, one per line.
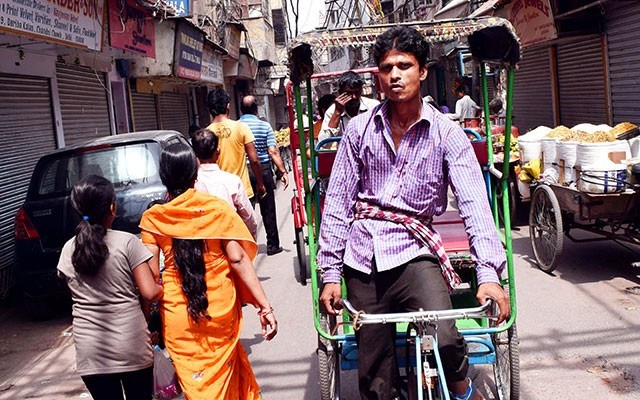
left=496, top=0, right=558, bottom=47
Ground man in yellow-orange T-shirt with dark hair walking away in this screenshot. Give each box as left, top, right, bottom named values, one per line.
left=207, top=88, right=266, bottom=202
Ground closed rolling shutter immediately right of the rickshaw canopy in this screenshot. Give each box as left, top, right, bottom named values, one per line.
left=513, top=46, right=554, bottom=133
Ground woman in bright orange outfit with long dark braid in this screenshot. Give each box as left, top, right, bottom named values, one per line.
left=140, top=143, right=277, bottom=400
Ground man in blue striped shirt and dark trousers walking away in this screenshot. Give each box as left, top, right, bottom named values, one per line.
left=240, top=96, right=289, bottom=256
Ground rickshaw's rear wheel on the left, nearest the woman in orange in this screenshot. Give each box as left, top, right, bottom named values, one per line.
left=318, top=313, right=340, bottom=400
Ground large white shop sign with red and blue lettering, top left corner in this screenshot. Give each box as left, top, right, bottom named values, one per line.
left=0, top=0, right=104, bottom=51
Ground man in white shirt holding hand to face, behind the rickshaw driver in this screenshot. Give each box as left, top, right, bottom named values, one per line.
left=318, top=71, right=380, bottom=141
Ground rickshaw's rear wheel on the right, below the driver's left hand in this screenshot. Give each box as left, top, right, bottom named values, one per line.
left=491, top=322, right=520, bottom=400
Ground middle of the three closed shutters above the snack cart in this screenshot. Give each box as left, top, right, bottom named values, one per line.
left=558, top=36, right=608, bottom=128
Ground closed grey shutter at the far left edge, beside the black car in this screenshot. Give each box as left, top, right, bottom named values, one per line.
left=0, top=74, right=56, bottom=297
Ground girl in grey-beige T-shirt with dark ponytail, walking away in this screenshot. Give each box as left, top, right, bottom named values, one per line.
left=58, top=175, right=162, bottom=400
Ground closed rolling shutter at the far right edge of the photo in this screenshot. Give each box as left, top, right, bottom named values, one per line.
left=606, top=2, right=640, bottom=125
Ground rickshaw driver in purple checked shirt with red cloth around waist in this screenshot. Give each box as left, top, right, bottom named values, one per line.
left=317, top=26, right=510, bottom=400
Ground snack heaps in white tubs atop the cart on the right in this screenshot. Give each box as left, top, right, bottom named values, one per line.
left=516, top=122, right=640, bottom=199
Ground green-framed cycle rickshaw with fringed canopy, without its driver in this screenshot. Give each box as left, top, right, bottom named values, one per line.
left=289, top=18, right=520, bottom=400
